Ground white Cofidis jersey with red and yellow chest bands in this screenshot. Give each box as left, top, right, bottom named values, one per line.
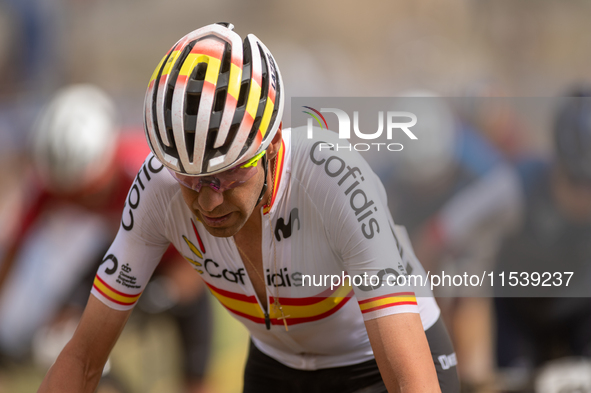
left=92, top=129, right=439, bottom=370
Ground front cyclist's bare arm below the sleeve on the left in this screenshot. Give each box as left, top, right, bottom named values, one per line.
left=38, top=295, right=132, bottom=393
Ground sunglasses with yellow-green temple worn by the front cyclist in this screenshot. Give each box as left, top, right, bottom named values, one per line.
left=168, top=151, right=265, bottom=192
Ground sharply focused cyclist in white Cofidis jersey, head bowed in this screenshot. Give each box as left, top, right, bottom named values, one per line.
left=40, top=23, right=459, bottom=392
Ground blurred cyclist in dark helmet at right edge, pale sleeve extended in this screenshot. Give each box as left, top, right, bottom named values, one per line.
left=410, top=89, right=591, bottom=391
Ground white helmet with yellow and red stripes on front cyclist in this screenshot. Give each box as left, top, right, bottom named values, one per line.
left=144, top=23, right=284, bottom=176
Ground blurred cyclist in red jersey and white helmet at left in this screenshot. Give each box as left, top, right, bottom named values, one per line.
left=0, top=85, right=211, bottom=393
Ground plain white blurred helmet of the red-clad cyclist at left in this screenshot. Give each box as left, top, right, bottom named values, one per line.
left=32, top=84, right=118, bottom=193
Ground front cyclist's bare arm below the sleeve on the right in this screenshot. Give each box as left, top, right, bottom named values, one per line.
left=365, top=313, right=441, bottom=393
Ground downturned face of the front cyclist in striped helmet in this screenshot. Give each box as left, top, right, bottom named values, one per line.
left=180, top=160, right=265, bottom=237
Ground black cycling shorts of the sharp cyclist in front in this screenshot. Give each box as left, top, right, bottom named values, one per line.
left=243, top=318, right=460, bottom=393
